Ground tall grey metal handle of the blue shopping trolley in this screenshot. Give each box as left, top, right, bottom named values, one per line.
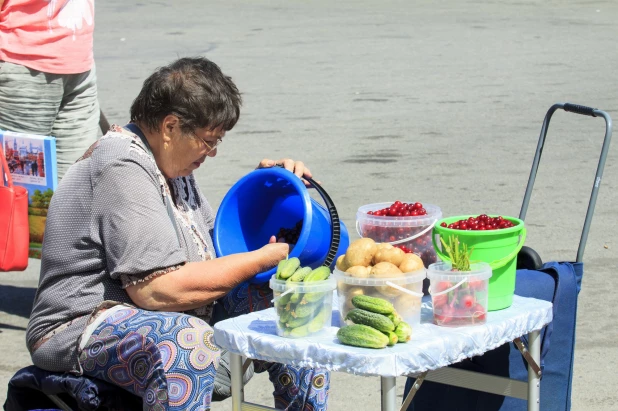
left=519, top=103, right=612, bottom=263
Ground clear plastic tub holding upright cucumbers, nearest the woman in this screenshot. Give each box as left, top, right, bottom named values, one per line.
left=270, top=276, right=337, bottom=338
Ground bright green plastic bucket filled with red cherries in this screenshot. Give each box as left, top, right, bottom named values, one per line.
left=432, top=215, right=526, bottom=311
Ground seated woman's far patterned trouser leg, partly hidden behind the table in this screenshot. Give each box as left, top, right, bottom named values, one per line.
left=214, top=283, right=330, bottom=411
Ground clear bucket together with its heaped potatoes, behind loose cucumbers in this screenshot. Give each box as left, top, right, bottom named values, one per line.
left=331, top=238, right=426, bottom=324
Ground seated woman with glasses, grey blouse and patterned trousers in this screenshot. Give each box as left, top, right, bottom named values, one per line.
left=27, top=58, right=329, bottom=410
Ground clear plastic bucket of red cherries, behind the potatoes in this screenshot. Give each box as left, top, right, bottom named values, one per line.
left=356, top=201, right=442, bottom=267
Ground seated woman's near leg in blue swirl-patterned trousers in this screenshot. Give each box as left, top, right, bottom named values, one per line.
left=79, top=308, right=220, bottom=411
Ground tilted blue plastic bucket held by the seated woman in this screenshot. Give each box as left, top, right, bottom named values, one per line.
left=213, top=168, right=349, bottom=283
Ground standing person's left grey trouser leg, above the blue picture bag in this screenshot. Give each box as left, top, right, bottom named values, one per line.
left=0, top=61, right=64, bottom=136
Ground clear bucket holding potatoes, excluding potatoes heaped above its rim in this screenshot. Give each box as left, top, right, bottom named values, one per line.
left=331, top=269, right=425, bottom=326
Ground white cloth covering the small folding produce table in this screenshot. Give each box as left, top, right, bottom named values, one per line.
left=214, top=296, right=552, bottom=377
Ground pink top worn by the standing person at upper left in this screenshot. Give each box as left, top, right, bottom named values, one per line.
left=0, top=0, right=94, bottom=74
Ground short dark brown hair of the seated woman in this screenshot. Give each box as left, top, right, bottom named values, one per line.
left=131, top=57, right=242, bottom=133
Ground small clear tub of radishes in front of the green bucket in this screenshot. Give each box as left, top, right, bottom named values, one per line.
left=427, top=262, right=492, bottom=327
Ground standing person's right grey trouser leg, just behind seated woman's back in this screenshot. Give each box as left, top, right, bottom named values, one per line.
left=52, top=66, right=99, bottom=179
